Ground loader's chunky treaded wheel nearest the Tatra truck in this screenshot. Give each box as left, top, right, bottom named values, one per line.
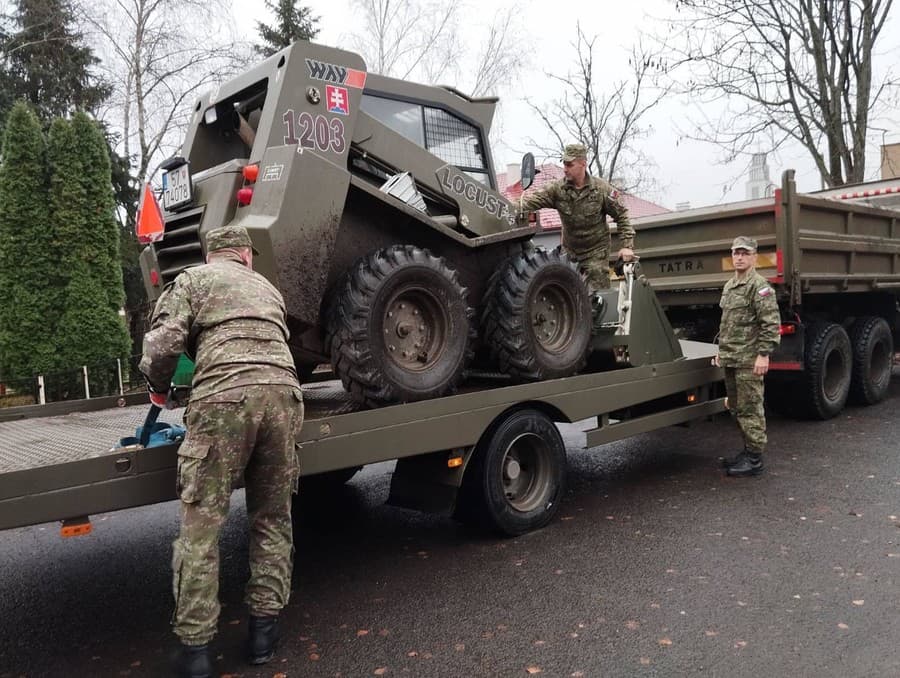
left=481, top=247, right=591, bottom=381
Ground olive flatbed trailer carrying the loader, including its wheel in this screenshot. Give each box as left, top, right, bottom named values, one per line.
left=0, top=341, right=724, bottom=535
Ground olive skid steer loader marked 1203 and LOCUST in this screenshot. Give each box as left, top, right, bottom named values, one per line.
left=139, top=42, right=652, bottom=406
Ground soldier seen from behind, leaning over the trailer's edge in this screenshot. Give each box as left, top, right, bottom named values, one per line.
left=141, top=226, right=303, bottom=678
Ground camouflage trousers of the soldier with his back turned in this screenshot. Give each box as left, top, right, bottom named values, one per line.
left=172, top=385, right=303, bottom=645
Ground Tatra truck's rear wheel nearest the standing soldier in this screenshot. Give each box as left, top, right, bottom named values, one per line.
left=804, top=322, right=853, bottom=419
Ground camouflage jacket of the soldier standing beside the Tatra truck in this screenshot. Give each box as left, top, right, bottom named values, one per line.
left=719, top=270, right=781, bottom=367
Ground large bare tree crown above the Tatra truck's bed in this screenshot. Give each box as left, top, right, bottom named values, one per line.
left=665, top=0, right=896, bottom=186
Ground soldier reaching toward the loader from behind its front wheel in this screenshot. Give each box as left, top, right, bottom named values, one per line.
left=520, top=144, right=634, bottom=292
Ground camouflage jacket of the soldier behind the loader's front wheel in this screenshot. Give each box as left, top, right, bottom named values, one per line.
left=521, top=176, right=634, bottom=258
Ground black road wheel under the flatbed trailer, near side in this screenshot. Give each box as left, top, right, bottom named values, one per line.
left=457, top=409, right=566, bottom=536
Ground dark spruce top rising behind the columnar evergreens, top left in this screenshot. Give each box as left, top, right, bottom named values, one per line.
left=0, top=0, right=111, bottom=131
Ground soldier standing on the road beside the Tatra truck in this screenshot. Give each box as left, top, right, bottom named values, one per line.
left=714, top=236, right=781, bottom=476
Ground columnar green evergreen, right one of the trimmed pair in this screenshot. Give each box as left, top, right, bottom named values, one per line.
left=48, top=113, right=130, bottom=392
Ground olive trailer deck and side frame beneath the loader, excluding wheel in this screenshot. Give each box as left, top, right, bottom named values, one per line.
left=0, top=341, right=724, bottom=529
